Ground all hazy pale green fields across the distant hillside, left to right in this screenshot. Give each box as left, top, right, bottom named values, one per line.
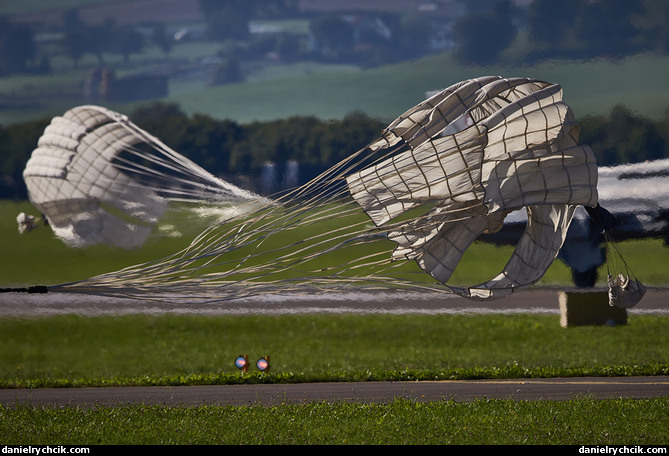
left=0, top=43, right=669, bottom=125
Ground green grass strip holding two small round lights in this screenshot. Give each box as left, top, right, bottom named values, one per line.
left=0, top=314, right=669, bottom=388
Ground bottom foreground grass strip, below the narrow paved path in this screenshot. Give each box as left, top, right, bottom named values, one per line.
left=0, top=398, right=669, bottom=445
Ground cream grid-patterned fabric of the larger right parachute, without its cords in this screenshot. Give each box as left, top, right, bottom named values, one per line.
left=347, top=78, right=597, bottom=297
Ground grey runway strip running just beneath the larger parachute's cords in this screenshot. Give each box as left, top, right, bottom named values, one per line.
left=0, top=287, right=669, bottom=317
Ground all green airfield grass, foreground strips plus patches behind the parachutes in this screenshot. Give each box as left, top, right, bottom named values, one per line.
left=0, top=196, right=669, bottom=445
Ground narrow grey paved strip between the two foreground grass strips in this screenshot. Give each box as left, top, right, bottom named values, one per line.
left=0, top=376, right=669, bottom=407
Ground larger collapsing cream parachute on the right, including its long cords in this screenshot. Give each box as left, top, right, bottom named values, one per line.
left=52, top=76, right=597, bottom=300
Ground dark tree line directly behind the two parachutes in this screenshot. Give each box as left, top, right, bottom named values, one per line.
left=0, top=102, right=669, bottom=199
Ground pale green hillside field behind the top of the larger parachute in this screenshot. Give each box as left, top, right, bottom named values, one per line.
left=171, top=50, right=669, bottom=122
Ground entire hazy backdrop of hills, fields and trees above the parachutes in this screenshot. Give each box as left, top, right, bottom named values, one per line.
left=0, top=0, right=669, bottom=198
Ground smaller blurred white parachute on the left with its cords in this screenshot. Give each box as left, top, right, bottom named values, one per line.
left=23, top=105, right=259, bottom=248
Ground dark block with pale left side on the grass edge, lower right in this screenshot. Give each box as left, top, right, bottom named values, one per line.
left=558, top=291, right=627, bottom=328
